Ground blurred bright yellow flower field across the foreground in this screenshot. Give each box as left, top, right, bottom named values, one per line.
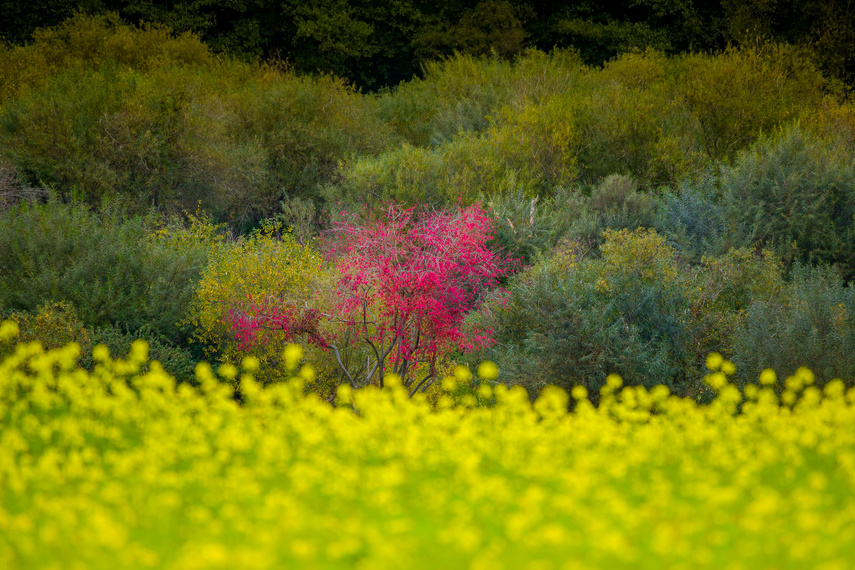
left=0, top=323, right=855, bottom=570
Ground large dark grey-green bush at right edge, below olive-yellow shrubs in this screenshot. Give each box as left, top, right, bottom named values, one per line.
left=721, top=126, right=855, bottom=279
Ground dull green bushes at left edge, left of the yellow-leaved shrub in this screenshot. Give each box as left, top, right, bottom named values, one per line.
left=0, top=202, right=207, bottom=342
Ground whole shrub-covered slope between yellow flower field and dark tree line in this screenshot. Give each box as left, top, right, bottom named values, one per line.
left=0, top=14, right=855, bottom=394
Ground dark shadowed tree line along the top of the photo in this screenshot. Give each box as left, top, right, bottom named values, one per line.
left=0, top=0, right=855, bottom=90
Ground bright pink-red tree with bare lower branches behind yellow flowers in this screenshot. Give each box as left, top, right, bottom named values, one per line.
left=226, top=205, right=507, bottom=395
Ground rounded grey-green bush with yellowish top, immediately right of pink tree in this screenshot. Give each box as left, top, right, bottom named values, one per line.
left=479, top=231, right=689, bottom=393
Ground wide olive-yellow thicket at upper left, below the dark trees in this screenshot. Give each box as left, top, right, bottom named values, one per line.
left=0, top=17, right=389, bottom=226
